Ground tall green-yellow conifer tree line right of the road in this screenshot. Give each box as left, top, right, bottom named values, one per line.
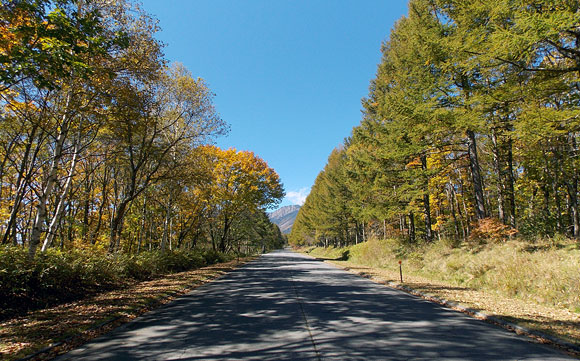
left=289, top=0, right=580, bottom=245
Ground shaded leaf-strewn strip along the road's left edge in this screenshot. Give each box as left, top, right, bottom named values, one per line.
left=0, top=257, right=253, bottom=360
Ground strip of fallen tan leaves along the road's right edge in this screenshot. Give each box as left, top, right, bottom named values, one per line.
left=302, top=248, right=580, bottom=357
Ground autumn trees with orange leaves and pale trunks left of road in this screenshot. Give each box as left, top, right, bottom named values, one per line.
left=0, top=0, right=284, bottom=258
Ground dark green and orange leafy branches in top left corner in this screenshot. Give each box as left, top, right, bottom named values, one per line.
left=0, top=0, right=127, bottom=89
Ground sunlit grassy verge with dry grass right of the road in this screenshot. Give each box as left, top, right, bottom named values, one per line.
left=303, top=240, right=580, bottom=346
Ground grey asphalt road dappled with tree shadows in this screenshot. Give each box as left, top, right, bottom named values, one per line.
left=59, top=251, right=569, bottom=360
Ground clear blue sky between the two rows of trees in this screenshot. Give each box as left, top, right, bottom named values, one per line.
left=142, top=0, right=407, bottom=205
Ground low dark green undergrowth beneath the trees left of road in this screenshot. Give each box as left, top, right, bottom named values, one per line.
left=0, top=246, right=232, bottom=318
